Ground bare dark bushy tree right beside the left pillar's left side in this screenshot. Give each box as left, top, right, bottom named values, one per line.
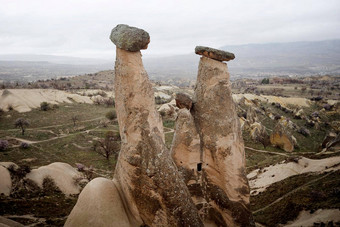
left=93, top=131, right=120, bottom=160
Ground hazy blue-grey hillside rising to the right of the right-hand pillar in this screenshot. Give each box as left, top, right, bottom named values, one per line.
left=221, top=40, right=340, bottom=75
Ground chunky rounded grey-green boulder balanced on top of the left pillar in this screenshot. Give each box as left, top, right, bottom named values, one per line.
left=110, top=24, right=150, bottom=52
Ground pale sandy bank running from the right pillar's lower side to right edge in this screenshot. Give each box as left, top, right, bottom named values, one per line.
left=247, top=157, right=340, bottom=195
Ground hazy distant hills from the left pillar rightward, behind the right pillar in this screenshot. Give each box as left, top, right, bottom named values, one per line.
left=144, top=40, right=340, bottom=80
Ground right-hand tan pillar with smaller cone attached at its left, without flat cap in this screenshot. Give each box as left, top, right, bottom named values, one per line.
left=172, top=52, right=254, bottom=226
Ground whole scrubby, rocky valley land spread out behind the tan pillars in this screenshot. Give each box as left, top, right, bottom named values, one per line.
left=0, top=77, right=340, bottom=226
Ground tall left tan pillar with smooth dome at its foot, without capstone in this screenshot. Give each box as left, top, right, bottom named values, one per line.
left=66, top=25, right=203, bottom=227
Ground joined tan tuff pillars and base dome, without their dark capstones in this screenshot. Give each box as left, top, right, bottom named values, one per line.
left=65, top=27, right=253, bottom=227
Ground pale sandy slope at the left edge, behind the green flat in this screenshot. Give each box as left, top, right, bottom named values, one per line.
left=0, top=89, right=93, bottom=112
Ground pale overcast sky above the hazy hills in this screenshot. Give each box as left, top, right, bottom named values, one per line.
left=0, top=0, right=340, bottom=59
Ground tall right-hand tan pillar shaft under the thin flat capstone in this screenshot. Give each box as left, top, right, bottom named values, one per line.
left=193, top=56, right=253, bottom=226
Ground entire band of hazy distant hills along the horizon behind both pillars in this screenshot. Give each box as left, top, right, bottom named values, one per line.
left=0, top=39, right=340, bottom=81
